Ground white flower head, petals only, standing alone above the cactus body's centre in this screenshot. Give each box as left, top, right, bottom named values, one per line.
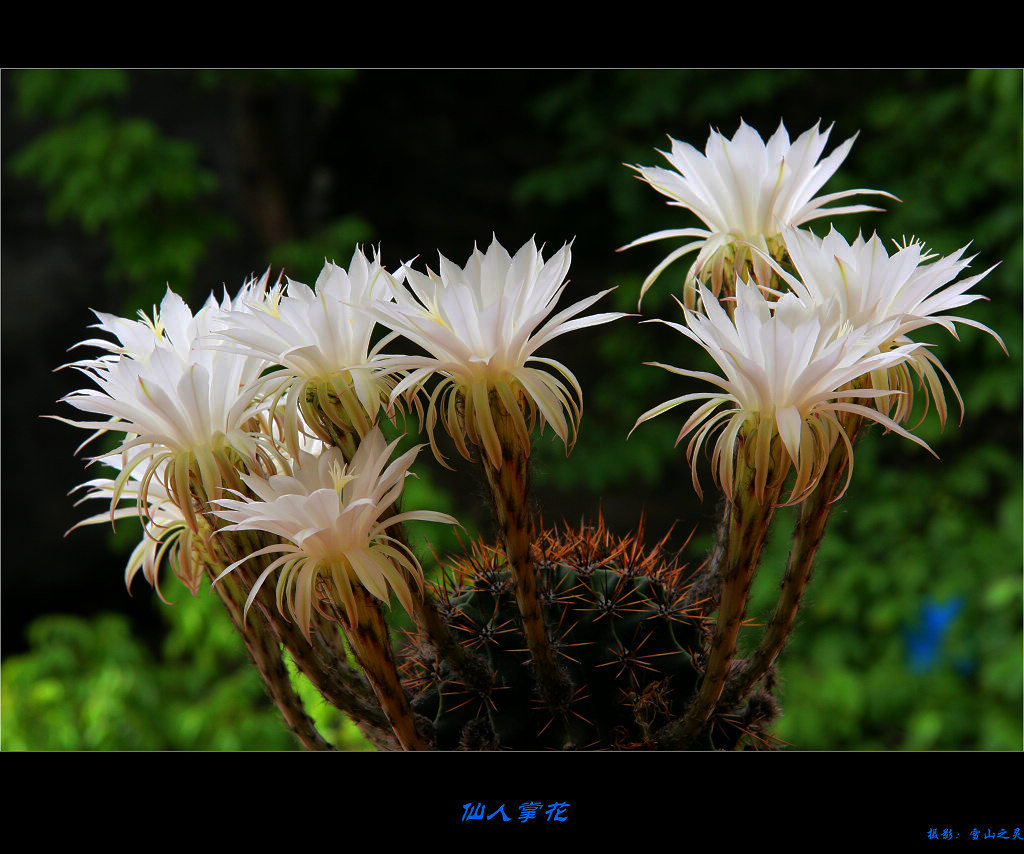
left=375, top=238, right=625, bottom=468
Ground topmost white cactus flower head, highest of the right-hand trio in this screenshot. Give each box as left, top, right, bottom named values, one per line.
left=624, top=122, right=895, bottom=307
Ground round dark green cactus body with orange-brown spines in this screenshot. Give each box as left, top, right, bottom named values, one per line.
left=403, top=520, right=778, bottom=750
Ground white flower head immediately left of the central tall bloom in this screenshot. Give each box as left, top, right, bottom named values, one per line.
left=211, top=247, right=405, bottom=453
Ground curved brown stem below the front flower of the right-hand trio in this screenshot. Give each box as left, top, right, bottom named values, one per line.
left=658, top=431, right=782, bottom=749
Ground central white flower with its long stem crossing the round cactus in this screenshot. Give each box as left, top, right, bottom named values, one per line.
left=374, top=238, right=624, bottom=707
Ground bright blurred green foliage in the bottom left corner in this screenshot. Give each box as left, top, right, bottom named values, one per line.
left=0, top=587, right=366, bottom=751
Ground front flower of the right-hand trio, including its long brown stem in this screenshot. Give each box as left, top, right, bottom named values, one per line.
left=634, top=281, right=927, bottom=745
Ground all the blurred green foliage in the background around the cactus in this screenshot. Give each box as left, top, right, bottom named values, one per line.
left=3, top=70, right=1024, bottom=750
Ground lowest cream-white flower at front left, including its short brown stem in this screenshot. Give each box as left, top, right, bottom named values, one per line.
left=214, top=427, right=458, bottom=749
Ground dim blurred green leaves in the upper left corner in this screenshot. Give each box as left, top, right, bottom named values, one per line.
left=10, top=70, right=236, bottom=299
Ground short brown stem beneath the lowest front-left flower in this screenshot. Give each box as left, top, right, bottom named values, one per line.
left=343, top=585, right=427, bottom=751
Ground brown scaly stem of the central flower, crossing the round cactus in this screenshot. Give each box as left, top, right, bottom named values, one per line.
left=481, top=398, right=572, bottom=710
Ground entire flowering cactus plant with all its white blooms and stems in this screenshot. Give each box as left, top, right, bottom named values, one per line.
left=60, top=118, right=1001, bottom=751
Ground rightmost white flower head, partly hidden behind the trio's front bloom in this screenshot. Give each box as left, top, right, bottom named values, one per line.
left=776, top=228, right=1006, bottom=424
